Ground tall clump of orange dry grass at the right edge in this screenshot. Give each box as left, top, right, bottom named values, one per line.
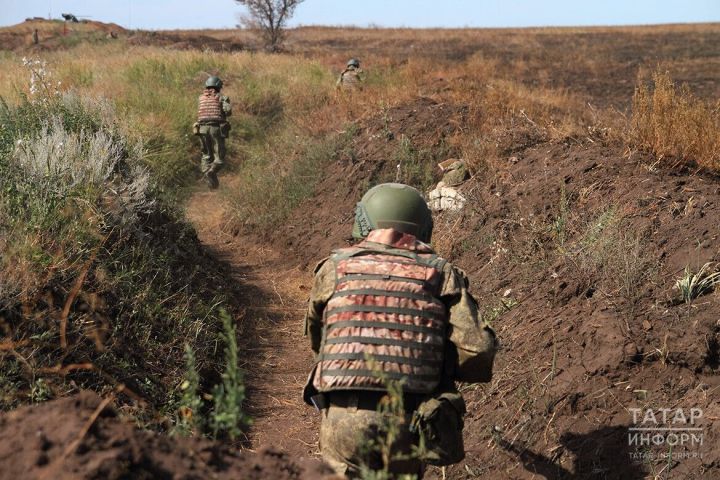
left=632, top=72, right=720, bottom=171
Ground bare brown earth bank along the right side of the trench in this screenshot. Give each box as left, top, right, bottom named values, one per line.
left=260, top=98, right=720, bottom=479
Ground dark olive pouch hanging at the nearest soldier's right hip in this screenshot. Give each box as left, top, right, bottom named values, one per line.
left=410, top=392, right=466, bottom=466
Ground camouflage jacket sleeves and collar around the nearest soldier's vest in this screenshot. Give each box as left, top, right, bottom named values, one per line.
left=305, top=229, right=496, bottom=402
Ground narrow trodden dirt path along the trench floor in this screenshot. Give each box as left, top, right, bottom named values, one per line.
left=186, top=190, right=318, bottom=457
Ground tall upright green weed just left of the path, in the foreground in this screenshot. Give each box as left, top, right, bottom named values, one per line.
left=211, top=310, right=249, bottom=440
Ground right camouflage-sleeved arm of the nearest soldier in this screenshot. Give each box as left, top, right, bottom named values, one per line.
left=443, top=265, right=497, bottom=383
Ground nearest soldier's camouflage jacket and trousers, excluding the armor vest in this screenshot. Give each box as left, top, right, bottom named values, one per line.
left=303, top=229, right=496, bottom=478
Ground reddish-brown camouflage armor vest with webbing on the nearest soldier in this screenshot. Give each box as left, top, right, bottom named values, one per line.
left=314, top=239, right=448, bottom=394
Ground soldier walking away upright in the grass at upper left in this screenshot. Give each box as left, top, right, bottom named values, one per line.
left=193, top=76, right=232, bottom=189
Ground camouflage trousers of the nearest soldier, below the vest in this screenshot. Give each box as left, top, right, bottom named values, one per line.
left=320, top=405, right=425, bottom=479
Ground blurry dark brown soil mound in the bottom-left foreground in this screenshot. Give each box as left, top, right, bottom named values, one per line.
left=0, top=391, right=332, bottom=480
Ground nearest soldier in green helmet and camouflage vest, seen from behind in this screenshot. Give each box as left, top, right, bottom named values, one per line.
left=303, top=183, right=496, bottom=478
